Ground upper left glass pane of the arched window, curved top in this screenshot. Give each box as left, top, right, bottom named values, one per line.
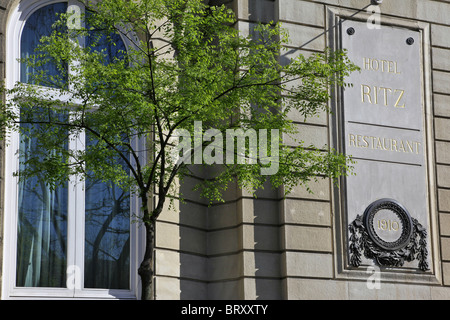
left=20, top=3, right=67, bottom=87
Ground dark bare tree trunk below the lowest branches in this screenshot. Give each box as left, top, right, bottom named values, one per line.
left=138, top=220, right=155, bottom=300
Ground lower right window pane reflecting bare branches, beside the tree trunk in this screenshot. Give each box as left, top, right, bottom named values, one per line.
left=84, top=138, right=130, bottom=289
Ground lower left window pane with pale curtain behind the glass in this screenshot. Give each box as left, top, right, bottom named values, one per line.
left=16, top=118, right=68, bottom=288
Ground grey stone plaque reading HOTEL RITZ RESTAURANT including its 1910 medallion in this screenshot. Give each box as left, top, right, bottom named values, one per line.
left=341, top=20, right=429, bottom=270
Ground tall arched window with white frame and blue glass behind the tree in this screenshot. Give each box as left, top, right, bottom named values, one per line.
left=3, top=0, right=137, bottom=298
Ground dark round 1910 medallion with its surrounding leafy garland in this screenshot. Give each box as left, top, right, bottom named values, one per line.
left=349, top=199, right=429, bottom=271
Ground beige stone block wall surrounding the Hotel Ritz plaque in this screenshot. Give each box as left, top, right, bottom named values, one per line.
left=0, top=0, right=450, bottom=300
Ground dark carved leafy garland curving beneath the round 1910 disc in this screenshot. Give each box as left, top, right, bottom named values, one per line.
left=349, top=215, right=429, bottom=271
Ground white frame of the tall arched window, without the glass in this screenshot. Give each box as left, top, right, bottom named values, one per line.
left=2, top=0, right=145, bottom=299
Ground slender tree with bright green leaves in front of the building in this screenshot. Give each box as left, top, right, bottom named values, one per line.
left=0, top=0, right=357, bottom=299
